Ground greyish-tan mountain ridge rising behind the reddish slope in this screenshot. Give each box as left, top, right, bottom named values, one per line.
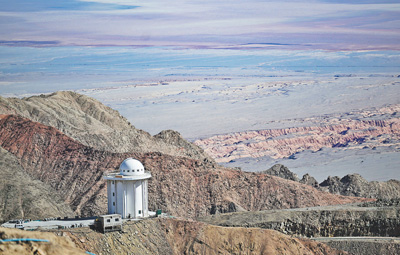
left=0, top=91, right=213, bottom=161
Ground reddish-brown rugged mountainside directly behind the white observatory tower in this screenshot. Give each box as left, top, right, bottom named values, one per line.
left=0, top=115, right=365, bottom=218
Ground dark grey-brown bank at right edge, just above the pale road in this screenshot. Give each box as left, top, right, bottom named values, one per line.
left=200, top=206, right=400, bottom=237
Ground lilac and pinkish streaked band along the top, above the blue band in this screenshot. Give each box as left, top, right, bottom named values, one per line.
left=0, top=0, right=400, bottom=50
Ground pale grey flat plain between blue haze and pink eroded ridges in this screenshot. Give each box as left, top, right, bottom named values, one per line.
left=78, top=75, right=400, bottom=137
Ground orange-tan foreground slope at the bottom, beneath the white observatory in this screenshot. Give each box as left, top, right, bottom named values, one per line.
left=64, top=218, right=347, bottom=255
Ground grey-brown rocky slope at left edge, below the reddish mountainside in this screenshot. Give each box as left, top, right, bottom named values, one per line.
left=0, top=148, right=74, bottom=223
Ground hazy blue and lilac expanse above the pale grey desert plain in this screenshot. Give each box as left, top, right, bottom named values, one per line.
left=0, top=0, right=400, bottom=96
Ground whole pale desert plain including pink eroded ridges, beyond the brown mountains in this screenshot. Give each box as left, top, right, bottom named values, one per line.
left=81, top=74, right=400, bottom=182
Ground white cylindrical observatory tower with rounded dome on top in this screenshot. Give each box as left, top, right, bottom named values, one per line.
left=104, top=158, right=151, bottom=219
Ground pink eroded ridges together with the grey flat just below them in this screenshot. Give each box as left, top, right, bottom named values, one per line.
left=194, top=102, right=400, bottom=181
